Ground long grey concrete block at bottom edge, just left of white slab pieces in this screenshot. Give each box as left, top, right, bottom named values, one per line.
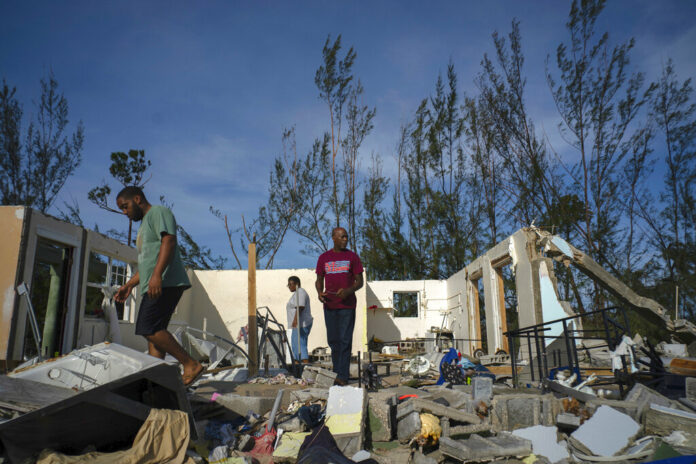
left=440, top=432, right=532, bottom=462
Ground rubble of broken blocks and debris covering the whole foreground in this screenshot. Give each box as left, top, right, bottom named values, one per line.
left=0, top=343, right=696, bottom=464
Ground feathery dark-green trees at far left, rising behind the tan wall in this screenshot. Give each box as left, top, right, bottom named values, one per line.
left=0, top=72, right=84, bottom=213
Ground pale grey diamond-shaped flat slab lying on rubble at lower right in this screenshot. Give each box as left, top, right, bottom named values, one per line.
left=571, top=406, right=640, bottom=456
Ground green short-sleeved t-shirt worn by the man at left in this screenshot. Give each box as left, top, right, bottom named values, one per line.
left=135, top=206, right=191, bottom=294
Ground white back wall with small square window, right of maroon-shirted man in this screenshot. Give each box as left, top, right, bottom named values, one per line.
left=367, top=280, right=448, bottom=341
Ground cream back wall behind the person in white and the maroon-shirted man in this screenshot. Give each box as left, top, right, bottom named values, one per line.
left=177, top=269, right=367, bottom=353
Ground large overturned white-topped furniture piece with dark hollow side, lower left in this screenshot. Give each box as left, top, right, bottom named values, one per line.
left=0, top=344, right=197, bottom=462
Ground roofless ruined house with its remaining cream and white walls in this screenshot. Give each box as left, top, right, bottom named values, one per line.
left=0, top=206, right=695, bottom=370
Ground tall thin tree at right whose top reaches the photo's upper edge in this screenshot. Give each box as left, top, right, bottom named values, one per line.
left=546, top=0, right=651, bottom=274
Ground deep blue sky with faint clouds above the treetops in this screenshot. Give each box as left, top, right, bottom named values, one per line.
left=0, top=0, right=696, bottom=268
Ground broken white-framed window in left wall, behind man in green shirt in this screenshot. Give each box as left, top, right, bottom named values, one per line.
left=85, top=252, right=134, bottom=321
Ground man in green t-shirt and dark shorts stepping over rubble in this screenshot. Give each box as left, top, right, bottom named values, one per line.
left=115, top=187, right=203, bottom=386
